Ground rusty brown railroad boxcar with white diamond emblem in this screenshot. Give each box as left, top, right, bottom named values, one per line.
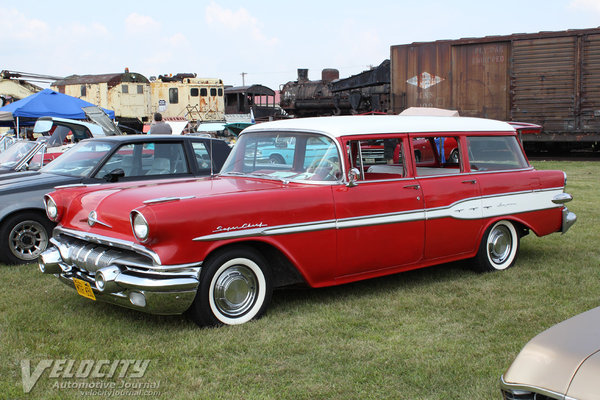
left=390, top=28, right=600, bottom=150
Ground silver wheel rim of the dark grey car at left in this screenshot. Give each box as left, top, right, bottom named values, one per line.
left=8, top=221, right=48, bottom=261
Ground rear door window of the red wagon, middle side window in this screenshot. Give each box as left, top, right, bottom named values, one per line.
left=411, top=136, right=461, bottom=176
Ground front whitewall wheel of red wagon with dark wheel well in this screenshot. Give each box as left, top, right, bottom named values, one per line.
left=188, top=246, right=273, bottom=326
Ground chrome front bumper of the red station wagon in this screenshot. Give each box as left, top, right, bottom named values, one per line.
left=38, top=236, right=201, bottom=315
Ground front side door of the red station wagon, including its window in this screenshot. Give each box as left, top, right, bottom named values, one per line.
left=333, top=136, right=425, bottom=278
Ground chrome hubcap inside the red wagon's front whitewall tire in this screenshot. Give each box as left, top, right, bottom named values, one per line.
left=213, top=265, right=258, bottom=317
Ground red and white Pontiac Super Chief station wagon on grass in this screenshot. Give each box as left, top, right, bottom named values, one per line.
left=39, top=116, right=576, bottom=325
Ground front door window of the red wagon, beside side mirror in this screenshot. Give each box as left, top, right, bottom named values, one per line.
left=347, top=138, right=406, bottom=181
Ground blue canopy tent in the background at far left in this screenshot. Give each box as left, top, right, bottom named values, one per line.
left=0, top=89, right=115, bottom=132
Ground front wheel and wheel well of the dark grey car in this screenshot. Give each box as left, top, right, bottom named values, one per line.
left=0, top=212, right=54, bottom=264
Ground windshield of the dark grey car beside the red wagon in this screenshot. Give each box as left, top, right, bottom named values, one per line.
left=41, top=140, right=113, bottom=177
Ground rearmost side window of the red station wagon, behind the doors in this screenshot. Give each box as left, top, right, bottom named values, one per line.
left=467, top=136, right=529, bottom=171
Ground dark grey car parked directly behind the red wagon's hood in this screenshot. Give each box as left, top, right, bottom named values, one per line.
left=0, top=135, right=230, bottom=264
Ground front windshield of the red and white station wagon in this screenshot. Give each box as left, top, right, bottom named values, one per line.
left=221, top=132, right=342, bottom=181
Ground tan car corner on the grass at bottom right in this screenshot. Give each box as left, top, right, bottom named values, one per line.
left=500, top=307, right=600, bottom=400
